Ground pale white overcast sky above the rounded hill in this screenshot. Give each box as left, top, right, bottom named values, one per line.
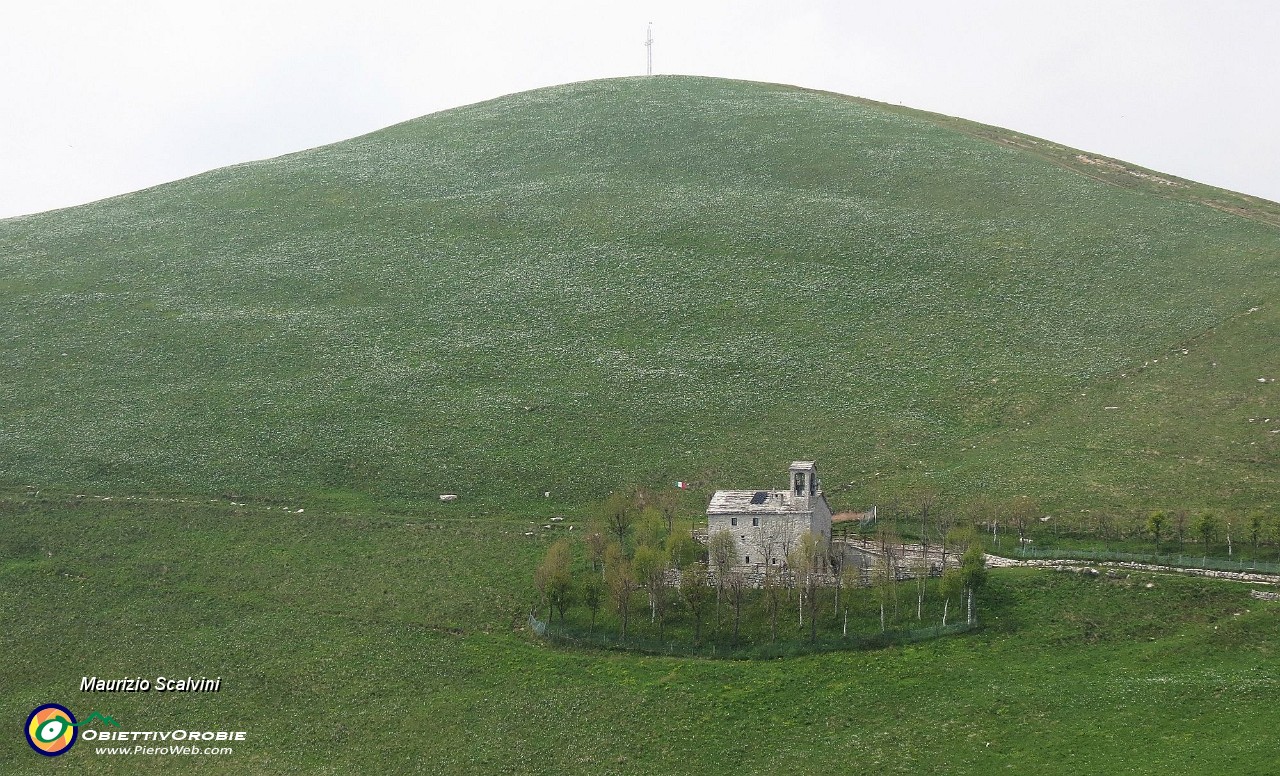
left=0, top=0, right=1280, bottom=218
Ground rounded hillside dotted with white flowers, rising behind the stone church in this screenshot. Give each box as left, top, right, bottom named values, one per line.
left=0, top=77, right=1280, bottom=510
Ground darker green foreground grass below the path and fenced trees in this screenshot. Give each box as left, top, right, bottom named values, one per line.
left=0, top=502, right=1280, bottom=773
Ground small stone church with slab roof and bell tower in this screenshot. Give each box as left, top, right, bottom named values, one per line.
left=707, top=461, right=831, bottom=569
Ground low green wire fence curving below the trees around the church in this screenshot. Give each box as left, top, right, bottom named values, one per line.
left=529, top=615, right=978, bottom=659
